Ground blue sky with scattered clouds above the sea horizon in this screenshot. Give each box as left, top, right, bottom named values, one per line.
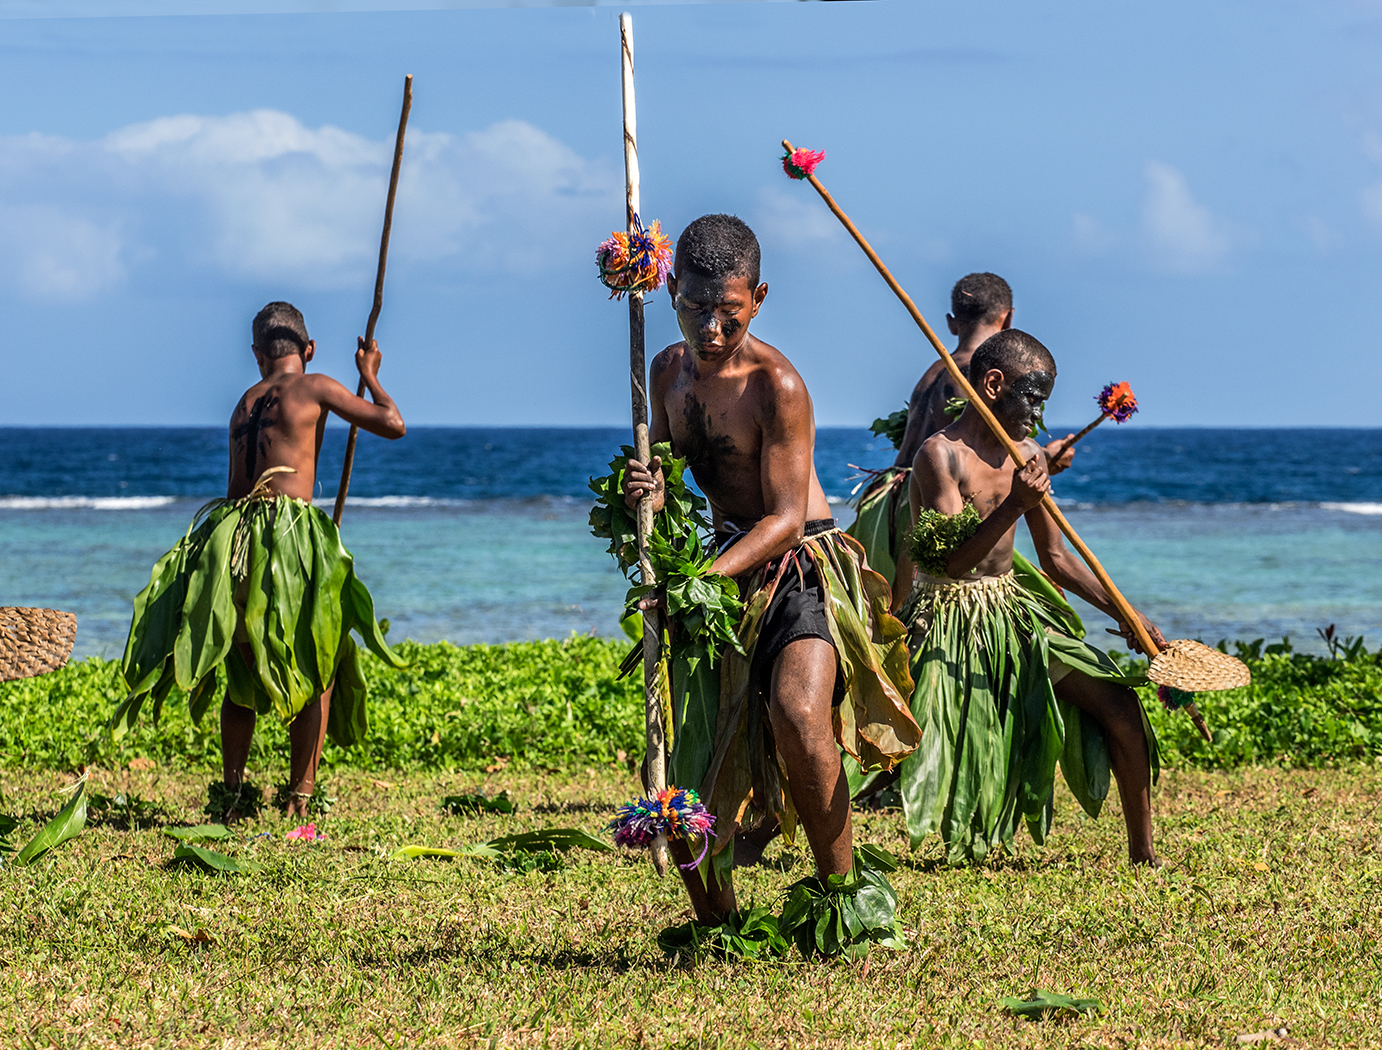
left=0, top=0, right=1382, bottom=425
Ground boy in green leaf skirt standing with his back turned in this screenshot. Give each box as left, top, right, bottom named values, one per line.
left=112, top=303, right=405, bottom=821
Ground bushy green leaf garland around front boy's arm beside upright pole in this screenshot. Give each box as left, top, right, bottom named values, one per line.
left=590, top=442, right=744, bottom=663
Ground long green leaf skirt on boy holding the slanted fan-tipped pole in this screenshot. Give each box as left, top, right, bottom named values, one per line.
left=901, top=572, right=1159, bottom=863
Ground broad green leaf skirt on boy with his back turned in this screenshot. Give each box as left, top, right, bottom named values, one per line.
left=111, top=495, right=406, bottom=747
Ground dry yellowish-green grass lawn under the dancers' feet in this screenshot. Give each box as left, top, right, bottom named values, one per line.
left=0, top=764, right=1382, bottom=1047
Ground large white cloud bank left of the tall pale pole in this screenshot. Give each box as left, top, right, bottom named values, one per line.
left=0, top=109, right=621, bottom=297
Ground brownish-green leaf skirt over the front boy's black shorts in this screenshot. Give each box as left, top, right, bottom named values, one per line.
left=668, top=529, right=920, bottom=876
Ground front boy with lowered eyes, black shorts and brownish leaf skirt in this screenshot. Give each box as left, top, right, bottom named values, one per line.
left=623, top=216, right=919, bottom=945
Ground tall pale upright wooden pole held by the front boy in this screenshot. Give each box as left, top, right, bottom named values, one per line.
left=619, top=12, right=668, bottom=875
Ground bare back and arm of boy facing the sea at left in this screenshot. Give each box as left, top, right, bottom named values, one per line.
left=225, top=338, right=406, bottom=503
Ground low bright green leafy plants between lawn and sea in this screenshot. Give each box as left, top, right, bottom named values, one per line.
left=0, top=636, right=1382, bottom=771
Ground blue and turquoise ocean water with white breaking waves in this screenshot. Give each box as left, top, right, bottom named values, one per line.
left=0, top=424, right=1382, bottom=655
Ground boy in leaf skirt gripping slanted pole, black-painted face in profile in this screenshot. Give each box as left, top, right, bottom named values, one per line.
left=901, top=329, right=1164, bottom=863
